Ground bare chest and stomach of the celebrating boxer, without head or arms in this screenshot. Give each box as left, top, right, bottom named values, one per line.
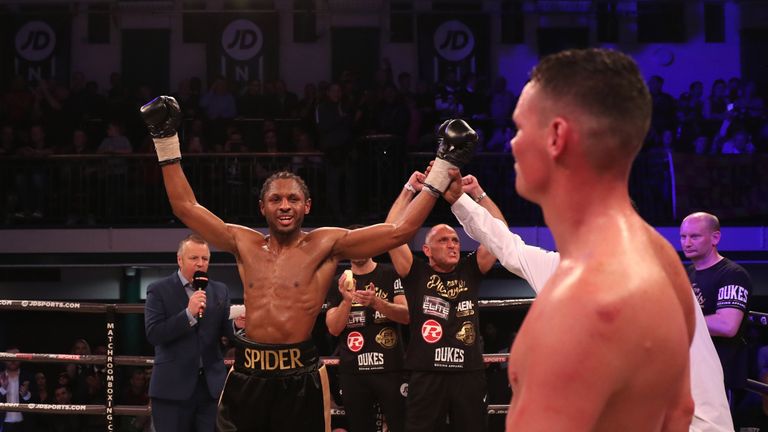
left=235, top=228, right=337, bottom=344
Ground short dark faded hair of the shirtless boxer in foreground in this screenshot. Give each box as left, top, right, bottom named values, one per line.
left=531, top=48, right=652, bottom=170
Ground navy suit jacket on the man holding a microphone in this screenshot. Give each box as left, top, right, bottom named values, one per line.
left=144, top=273, right=233, bottom=400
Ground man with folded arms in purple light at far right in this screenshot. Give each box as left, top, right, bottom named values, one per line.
left=680, top=212, right=752, bottom=407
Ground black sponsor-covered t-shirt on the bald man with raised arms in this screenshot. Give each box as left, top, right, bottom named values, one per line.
left=403, top=252, right=483, bottom=371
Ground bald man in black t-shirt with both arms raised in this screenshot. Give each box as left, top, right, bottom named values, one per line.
left=387, top=173, right=496, bottom=432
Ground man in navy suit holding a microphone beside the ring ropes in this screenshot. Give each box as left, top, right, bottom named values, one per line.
left=144, top=234, right=233, bottom=432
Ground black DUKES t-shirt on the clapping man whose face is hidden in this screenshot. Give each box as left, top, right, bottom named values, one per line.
left=328, top=264, right=403, bottom=373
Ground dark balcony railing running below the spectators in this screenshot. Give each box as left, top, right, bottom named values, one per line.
left=0, top=140, right=768, bottom=227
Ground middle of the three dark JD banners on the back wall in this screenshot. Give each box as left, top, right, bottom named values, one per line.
left=207, top=12, right=279, bottom=86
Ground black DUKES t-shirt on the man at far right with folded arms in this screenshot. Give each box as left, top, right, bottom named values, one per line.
left=688, top=258, right=752, bottom=388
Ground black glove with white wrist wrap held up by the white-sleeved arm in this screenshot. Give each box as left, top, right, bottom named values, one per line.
left=424, top=119, right=477, bottom=195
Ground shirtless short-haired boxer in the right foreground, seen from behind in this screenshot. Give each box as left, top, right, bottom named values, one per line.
left=507, top=49, right=694, bottom=431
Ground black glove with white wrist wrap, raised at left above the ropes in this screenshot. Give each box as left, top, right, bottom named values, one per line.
left=140, top=96, right=181, bottom=166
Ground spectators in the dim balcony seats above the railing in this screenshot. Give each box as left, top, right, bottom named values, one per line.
left=0, top=60, right=768, bottom=156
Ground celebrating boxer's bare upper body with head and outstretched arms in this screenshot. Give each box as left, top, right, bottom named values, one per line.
left=162, top=164, right=435, bottom=344
